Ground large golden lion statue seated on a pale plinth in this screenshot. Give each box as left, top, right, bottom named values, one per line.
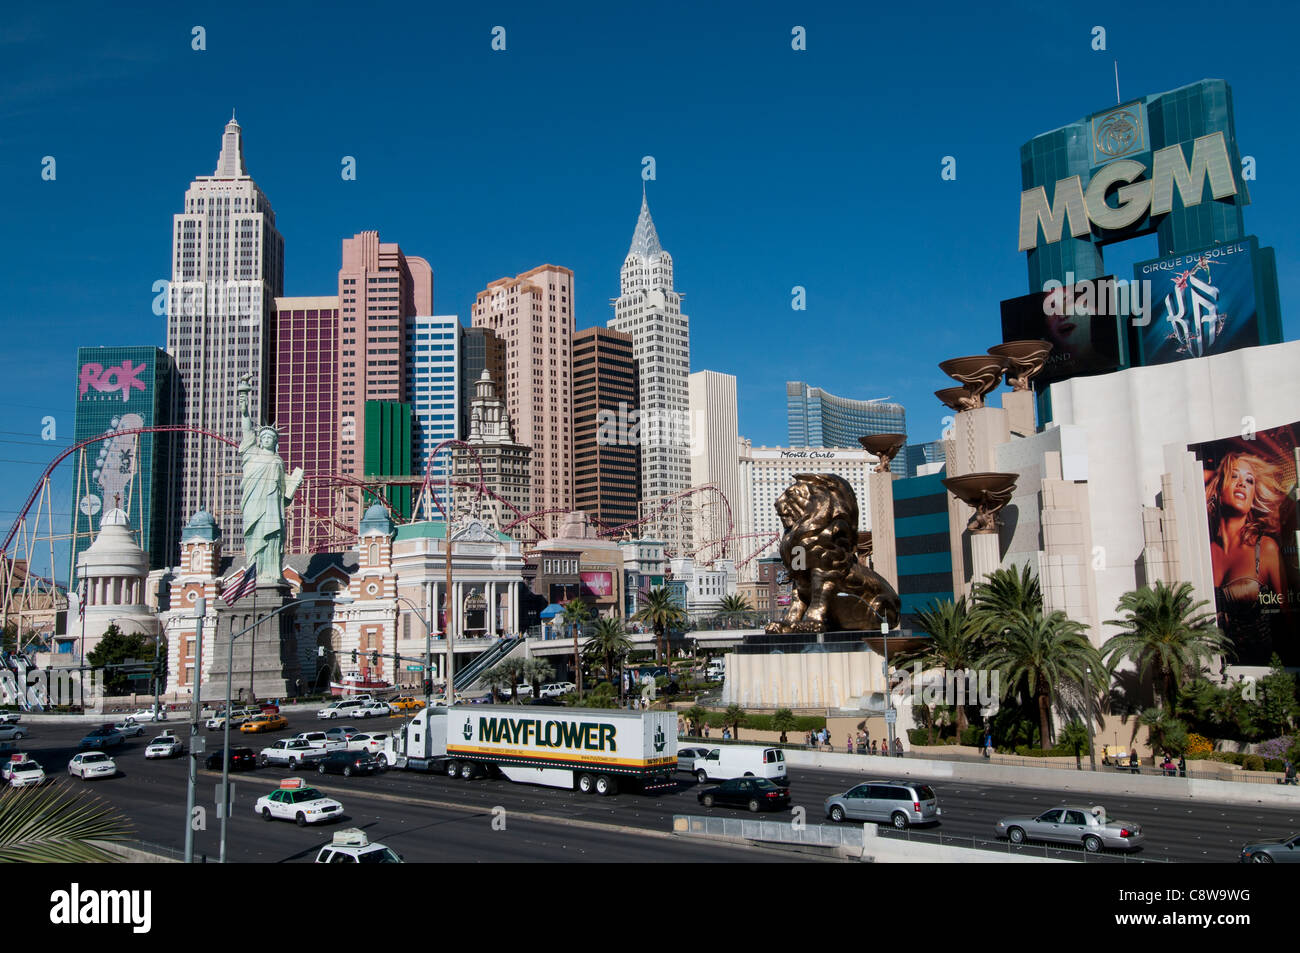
left=767, top=473, right=900, bottom=632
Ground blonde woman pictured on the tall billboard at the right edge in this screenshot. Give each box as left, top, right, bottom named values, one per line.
left=1205, top=451, right=1287, bottom=664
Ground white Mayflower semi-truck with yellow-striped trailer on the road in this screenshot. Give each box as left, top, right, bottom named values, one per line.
left=389, top=705, right=677, bottom=794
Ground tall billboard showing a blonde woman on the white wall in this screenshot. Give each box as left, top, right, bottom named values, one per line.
left=1190, top=423, right=1300, bottom=666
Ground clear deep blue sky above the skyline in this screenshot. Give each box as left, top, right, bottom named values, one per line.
left=0, top=3, right=1300, bottom=564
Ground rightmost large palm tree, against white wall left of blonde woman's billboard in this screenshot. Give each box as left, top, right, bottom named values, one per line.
left=1101, top=581, right=1232, bottom=710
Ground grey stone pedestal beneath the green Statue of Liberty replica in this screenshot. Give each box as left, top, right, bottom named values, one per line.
left=203, top=582, right=299, bottom=705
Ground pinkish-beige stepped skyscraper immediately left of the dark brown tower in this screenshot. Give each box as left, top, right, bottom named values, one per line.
left=471, top=265, right=573, bottom=534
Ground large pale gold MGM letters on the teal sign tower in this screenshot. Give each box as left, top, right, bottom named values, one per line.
left=1021, top=133, right=1238, bottom=251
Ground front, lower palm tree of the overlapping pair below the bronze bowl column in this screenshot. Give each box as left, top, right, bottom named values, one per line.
left=979, top=611, right=1108, bottom=750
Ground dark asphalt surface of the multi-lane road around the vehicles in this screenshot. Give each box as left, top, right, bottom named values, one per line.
left=12, top=712, right=1300, bottom=862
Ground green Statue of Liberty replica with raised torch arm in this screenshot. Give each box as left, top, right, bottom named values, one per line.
left=237, top=377, right=303, bottom=585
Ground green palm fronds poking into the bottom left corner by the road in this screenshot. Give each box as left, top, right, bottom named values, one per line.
left=0, top=781, right=130, bottom=863
